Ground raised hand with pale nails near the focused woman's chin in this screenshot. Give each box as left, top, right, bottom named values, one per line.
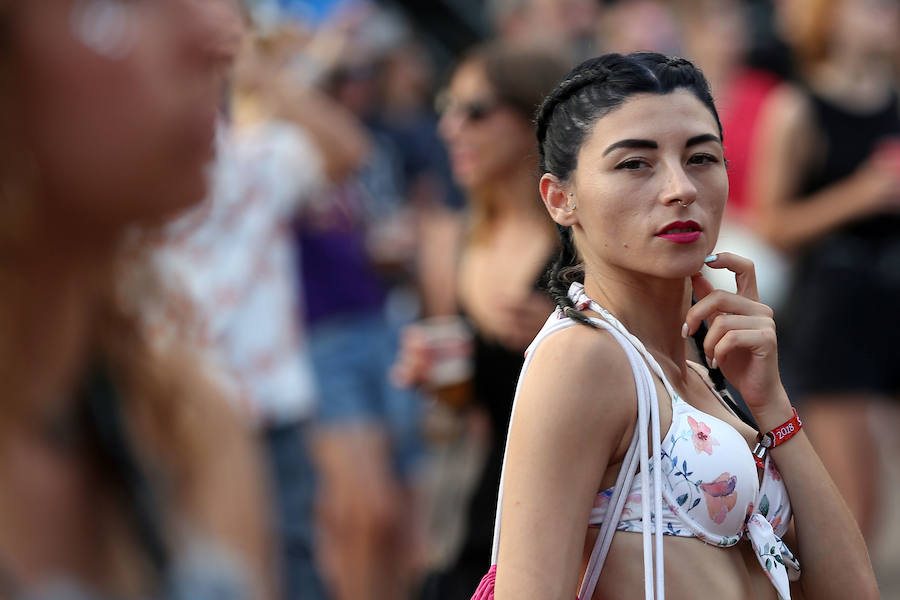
left=685, top=252, right=789, bottom=419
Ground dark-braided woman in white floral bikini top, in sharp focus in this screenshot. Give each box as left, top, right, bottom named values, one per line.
left=481, top=53, right=878, bottom=600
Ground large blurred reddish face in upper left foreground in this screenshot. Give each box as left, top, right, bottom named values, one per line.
left=11, top=0, right=241, bottom=231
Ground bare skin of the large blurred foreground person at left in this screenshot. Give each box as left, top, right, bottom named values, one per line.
left=0, top=0, right=271, bottom=597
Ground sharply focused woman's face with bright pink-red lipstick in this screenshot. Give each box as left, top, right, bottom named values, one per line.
left=565, top=90, right=728, bottom=278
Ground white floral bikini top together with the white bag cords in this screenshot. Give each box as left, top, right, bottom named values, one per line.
left=486, top=283, right=800, bottom=600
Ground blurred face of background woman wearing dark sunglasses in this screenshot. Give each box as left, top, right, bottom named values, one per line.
left=440, top=62, right=537, bottom=193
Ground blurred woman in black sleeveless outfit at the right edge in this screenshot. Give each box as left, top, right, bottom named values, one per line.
left=750, top=0, right=900, bottom=537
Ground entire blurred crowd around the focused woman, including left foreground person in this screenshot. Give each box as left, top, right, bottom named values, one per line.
left=0, top=0, right=900, bottom=600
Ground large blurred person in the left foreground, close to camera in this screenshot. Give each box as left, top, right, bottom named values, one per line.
left=0, top=0, right=271, bottom=599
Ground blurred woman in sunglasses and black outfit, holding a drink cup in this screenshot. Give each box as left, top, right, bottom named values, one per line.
left=395, top=43, right=566, bottom=598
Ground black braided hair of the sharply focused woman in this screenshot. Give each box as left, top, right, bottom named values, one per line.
left=537, top=52, right=722, bottom=327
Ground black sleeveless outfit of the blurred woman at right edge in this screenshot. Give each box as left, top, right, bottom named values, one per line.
left=778, top=93, right=900, bottom=401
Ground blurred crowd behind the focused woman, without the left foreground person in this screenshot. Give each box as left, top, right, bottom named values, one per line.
left=0, top=0, right=900, bottom=600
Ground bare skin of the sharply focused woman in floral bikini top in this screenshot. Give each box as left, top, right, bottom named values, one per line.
left=488, top=90, right=878, bottom=600
